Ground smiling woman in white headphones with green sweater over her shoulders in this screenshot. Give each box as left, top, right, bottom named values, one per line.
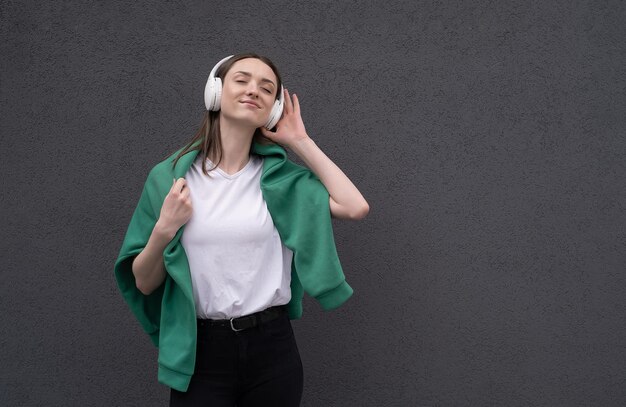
left=115, top=54, right=369, bottom=406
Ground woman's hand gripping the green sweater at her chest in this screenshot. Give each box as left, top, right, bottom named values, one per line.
left=157, top=178, right=193, bottom=237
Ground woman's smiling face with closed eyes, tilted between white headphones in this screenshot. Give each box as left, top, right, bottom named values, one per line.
left=220, top=58, right=279, bottom=128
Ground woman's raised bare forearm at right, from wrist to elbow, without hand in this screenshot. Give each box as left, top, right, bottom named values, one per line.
left=289, top=137, right=369, bottom=219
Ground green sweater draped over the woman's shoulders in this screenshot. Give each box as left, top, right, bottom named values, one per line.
left=115, top=143, right=352, bottom=391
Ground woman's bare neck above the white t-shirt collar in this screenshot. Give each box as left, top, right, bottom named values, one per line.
left=211, top=116, right=256, bottom=174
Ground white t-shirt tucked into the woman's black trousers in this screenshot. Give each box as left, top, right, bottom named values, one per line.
left=181, top=155, right=293, bottom=319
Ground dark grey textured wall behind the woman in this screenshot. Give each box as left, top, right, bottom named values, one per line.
left=0, top=0, right=626, bottom=406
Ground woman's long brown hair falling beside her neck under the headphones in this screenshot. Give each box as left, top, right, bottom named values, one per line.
left=172, top=53, right=282, bottom=175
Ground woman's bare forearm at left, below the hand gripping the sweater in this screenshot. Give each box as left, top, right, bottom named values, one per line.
left=132, top=222, right=173, bottom=295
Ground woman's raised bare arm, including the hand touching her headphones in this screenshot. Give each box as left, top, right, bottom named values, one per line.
left=261, top=89, right=369, bottom=220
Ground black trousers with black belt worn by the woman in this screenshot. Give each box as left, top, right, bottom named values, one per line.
left=170, top=313, right=303, bottom=407
